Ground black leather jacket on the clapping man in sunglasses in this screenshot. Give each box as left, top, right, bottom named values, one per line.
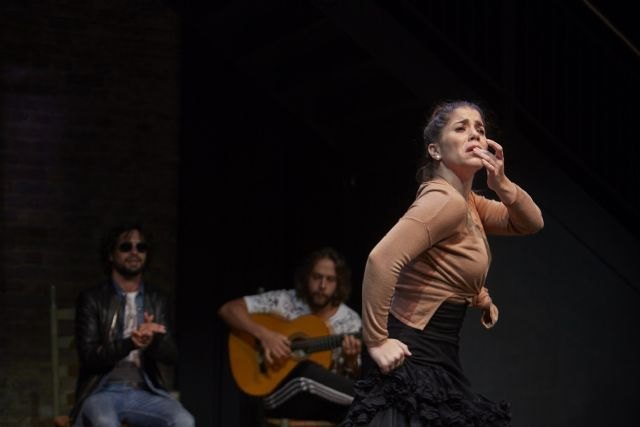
left=71, top=282, right=177, bottom=419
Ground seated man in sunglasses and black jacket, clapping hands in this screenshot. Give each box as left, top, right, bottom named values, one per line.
left=71, top=225, right=195, bottom=427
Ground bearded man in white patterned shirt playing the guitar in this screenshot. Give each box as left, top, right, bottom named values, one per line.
left=218, top=248, right=362, bottom=422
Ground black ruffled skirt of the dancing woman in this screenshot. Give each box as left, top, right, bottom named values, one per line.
left=341, top=302, right=511, bottom=427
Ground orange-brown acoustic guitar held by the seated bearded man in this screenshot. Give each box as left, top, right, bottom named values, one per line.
left=229, top=314, right=360, bottom=396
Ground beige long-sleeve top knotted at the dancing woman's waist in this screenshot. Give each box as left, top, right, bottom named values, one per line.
left=362, top=179, right=543, bottom=346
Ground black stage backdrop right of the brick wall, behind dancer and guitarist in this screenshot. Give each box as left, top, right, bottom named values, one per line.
left=179, top=1, right=638, bottom=426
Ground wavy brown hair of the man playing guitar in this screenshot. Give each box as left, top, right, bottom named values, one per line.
left=294, top=247, right=351, bottom=306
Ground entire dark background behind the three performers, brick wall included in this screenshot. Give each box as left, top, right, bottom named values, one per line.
left=0, top=0, right=640, bottom=426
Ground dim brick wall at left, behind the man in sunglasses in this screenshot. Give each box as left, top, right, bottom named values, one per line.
left=0, top=0, right=179, bottom=427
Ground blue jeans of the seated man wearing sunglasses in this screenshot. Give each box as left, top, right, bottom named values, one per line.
left=74, top=384, right=195, bottom=427
